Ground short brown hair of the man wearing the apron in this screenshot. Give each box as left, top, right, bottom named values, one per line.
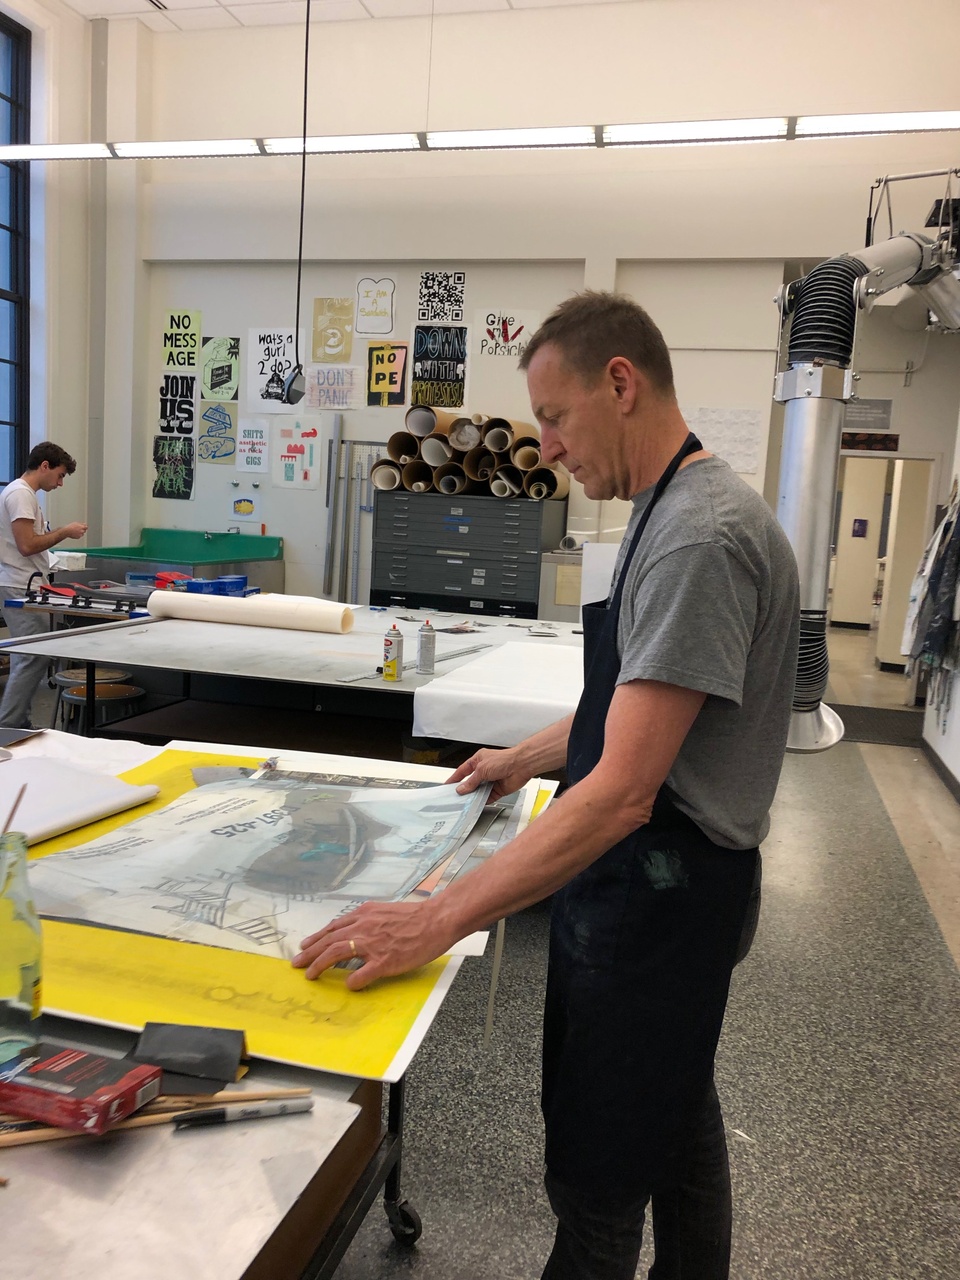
left=520, top=289, right=673, bottom=396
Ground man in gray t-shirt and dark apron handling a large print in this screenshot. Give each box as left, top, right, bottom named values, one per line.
left=293, top=293, right=799, bottom=1280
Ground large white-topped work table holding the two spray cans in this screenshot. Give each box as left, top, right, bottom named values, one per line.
left=4, top=608, right=582, bottom=741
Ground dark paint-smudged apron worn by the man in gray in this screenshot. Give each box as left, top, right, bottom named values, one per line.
left=541, top=434, right=759, bottom=1203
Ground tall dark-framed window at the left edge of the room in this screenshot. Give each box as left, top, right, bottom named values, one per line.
left=0, top=14, right=29, bottom=485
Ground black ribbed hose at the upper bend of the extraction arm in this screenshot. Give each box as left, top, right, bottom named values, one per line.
left=787, top=253, right=869, bottom=369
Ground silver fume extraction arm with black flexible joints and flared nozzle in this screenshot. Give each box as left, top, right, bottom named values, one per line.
left=774, top=169, right=960, bottom=751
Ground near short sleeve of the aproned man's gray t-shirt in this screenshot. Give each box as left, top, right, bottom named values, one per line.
left=617, top=543, right=758, bottom=707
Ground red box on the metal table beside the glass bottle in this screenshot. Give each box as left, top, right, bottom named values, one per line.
left=0, top=1041, right=163, bottom=1133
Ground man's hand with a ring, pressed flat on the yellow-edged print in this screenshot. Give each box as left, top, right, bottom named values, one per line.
left=293, top=902, right=457, bottom=991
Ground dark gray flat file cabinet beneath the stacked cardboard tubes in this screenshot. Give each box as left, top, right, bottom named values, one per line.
left=370, top=489, right=567, bottom=618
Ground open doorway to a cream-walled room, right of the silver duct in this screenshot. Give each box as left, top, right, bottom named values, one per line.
left=827, top=454, right=933, bottom=710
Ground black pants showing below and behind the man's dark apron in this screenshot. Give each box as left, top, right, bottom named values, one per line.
left=543, top=858, right=760, bottom=1280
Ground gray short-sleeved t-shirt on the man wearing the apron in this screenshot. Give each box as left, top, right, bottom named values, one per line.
left=616, top=457, right=800, bottom=849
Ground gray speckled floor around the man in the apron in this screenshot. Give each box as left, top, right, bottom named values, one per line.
left=338, top=744, right=960, bottom=1280
